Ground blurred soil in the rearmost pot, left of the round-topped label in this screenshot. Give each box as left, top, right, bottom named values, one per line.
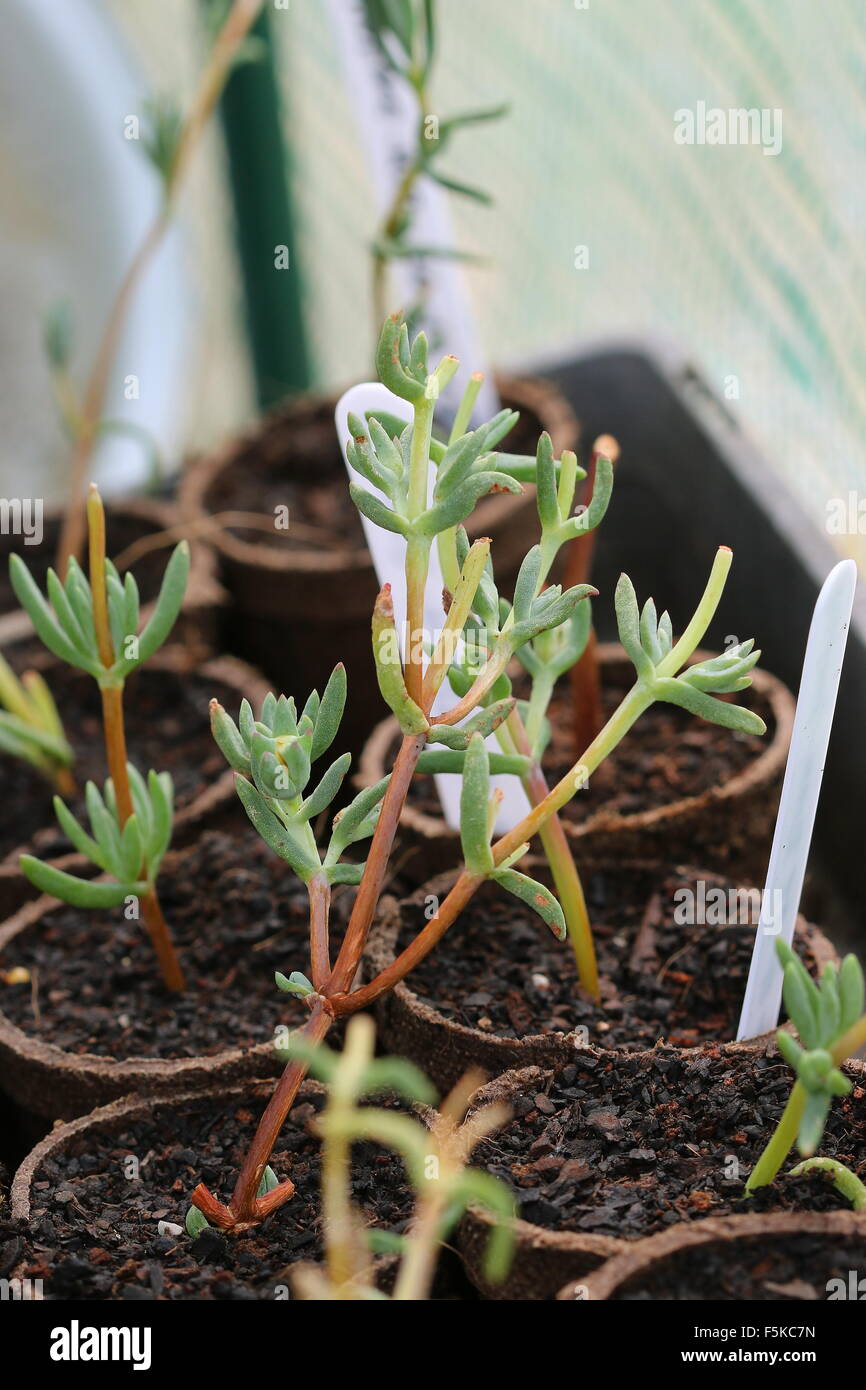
left=204, top=391, right=542, bottom=552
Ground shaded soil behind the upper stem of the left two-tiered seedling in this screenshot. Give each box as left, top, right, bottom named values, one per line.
left=0, top=664, right=239, bottom=859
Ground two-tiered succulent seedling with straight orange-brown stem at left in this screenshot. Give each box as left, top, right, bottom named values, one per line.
left=10, top=485, right=189, bottom=990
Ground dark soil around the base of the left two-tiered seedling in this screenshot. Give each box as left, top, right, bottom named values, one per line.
left=0, top=826, right=352, bottom=1058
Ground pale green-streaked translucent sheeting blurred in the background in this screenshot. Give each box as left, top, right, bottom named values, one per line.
left=113, top=0, right=866, bottom=557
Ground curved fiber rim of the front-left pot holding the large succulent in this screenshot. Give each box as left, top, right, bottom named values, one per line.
left=10, top=1077, right=325, bottom=1222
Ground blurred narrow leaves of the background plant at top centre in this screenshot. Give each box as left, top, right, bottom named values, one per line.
left=364, top=0, right=507, bottom=260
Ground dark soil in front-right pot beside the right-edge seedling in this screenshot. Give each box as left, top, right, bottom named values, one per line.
left=474, top=1048, right=866, bottom=1240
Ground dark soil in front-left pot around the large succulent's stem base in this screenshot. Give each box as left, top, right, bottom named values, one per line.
left=16, top=1095, right=411, bottom=1300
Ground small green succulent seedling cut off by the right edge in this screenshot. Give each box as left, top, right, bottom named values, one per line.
left=745, top=940, right=866, bottom=1193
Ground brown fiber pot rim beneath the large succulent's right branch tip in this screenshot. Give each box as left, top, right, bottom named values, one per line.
left=354, top=642, right=796, bottom=842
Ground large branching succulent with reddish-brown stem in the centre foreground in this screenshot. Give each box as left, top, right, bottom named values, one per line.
left=192, top=314, right=763, bottom=1230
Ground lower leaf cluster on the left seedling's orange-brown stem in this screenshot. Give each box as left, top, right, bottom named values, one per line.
left=19, top=763, right=174, bottom=908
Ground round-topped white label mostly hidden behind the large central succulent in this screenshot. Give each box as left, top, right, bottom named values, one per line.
left=335, top=381, right=530, bottom=834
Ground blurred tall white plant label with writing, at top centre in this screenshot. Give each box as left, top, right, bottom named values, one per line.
left=328, top=0, right=499, bottom=420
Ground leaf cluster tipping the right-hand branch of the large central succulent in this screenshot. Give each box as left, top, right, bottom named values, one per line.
left=614, top=574, right=766, bottom=734
